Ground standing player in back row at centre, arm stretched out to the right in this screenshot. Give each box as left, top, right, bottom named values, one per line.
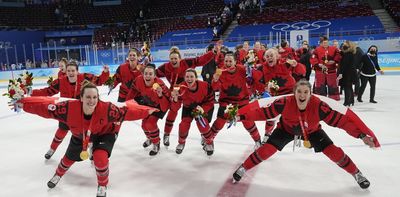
left=156, top=44, right=221, bottom=146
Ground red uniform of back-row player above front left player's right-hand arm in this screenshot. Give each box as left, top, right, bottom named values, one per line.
left=113, top=61, right=142, bottom=102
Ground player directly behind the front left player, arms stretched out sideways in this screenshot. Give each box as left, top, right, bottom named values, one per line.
left=31, top=62, right=110, bottom=159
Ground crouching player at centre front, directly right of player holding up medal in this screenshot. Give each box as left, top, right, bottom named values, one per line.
left=171, top=68, right=214, bottom=154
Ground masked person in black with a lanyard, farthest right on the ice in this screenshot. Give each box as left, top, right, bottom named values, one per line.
left=357, top=45, right=383, bottom=103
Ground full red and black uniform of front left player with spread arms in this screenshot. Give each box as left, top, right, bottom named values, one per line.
left=21, top=97, right=150, bottom=190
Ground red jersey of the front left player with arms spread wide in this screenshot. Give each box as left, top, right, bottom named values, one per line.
left=20, top=97, right=155, bottom=138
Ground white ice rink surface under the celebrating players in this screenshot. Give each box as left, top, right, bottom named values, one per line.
left=0, top=75, right=400, bottom=197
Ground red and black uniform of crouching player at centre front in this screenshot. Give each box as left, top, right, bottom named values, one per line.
left=171, top=81, right=214, bottom=149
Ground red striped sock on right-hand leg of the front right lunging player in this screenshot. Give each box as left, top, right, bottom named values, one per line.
left=323, top=144, right=358, bottom=174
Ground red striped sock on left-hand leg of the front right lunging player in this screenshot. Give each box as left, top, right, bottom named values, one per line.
left=243, top=143, right=277, bottom=170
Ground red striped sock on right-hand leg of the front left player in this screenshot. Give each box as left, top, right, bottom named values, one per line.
left=93, top=149, right=109, bottom=186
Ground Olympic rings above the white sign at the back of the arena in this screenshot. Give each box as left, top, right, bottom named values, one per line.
left=272, top=20, right=332, bottom=31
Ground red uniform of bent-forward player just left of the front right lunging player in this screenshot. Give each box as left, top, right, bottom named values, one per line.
left=204, top=64, right=260, bottom=146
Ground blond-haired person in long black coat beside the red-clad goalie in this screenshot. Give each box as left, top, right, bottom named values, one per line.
left=338, top=40, right=357, bottom=106
